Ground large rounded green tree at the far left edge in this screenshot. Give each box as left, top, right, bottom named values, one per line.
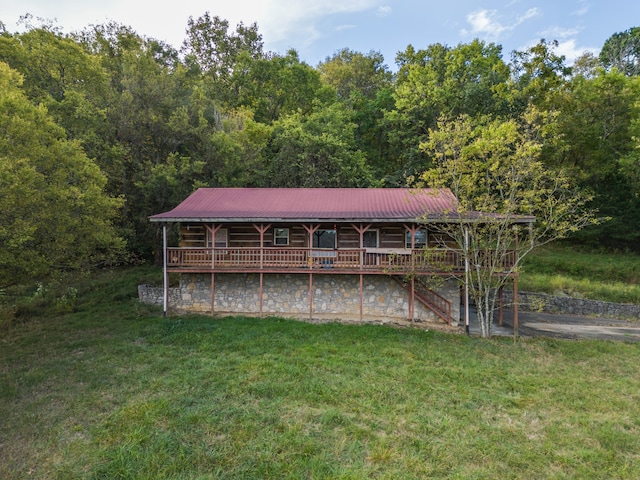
left=0, top=62, right=124, bottom=288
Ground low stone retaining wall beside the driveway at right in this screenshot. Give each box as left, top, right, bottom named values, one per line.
left=504, top=290, right=640, bottom=320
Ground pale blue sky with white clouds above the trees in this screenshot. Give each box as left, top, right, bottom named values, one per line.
left=0, top=0, right=640, bottom=70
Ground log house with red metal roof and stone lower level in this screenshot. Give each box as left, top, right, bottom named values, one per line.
left=150, top=188, right=524, bottom=324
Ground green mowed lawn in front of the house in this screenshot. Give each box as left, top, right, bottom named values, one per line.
left=0, top=268, right=640, bottom=479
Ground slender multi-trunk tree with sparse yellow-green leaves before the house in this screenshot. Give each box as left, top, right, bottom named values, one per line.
left=418, top=109, right=594, bottom=337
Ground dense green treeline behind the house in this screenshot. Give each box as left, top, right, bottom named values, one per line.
left=0, top=13, right=640, bottom=287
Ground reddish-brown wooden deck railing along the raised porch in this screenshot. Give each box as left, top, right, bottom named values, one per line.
left=167, top=247, right=515, bottom=273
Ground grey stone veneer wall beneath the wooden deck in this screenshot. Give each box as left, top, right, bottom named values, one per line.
left=138, top=273, right=460, bottom=322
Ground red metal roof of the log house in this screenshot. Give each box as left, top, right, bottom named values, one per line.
left=150, top=188, right=457, bottom=222
